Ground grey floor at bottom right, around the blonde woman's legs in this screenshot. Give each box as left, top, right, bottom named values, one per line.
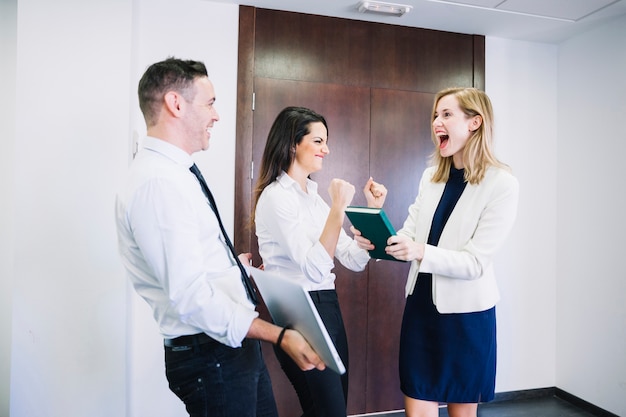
left=360, top=397, right=594, bottom=417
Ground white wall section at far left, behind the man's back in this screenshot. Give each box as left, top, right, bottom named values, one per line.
left=10, top=0, right=131, bottom=417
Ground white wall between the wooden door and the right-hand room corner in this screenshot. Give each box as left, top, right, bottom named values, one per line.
left=485, top=38, right=557, bottom=392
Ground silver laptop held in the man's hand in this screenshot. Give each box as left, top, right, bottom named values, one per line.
left=250, top=267, right=346, bottom=375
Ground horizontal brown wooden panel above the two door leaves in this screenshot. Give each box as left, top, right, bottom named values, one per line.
left=255, top=9, right=484, bottom=93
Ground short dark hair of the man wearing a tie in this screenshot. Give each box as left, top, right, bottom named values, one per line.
left=137, top=57, right=208, bottom=127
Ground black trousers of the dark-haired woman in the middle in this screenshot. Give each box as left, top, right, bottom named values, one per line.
left=274, top=290, right=349, bottom=417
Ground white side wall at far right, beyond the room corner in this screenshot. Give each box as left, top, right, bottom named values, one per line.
left=551, top=16, right=626, bottom=416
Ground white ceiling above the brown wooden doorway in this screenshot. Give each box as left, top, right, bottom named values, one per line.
left=206, top=0, right=626, bottom=43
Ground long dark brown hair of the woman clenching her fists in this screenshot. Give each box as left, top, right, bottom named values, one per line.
left=249, top=106, right=328, bottom=227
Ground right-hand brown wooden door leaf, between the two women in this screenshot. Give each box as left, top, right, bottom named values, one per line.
left=366, top=89, right=433, bottom=412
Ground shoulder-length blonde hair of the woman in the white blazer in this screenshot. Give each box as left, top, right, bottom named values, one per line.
left=431, top=87, right=510, bottom=184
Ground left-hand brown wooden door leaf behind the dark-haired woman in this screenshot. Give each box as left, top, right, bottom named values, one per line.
left=252, top=78, right=370, bottom=415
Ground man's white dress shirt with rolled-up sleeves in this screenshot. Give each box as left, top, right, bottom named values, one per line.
left=116, top=137, right=258, bottom=347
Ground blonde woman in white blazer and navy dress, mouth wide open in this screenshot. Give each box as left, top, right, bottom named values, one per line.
left=355, top=88, right=518, bottom=417
